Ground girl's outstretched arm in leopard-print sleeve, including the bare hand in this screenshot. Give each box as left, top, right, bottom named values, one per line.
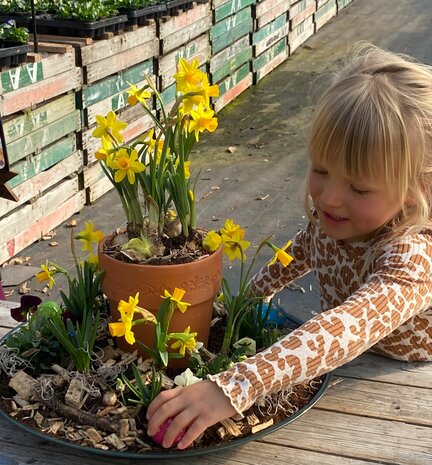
left=148, top=236, right=432, bottom=449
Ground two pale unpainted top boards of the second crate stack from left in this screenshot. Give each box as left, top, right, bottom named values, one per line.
left=77, top=21, right=159, bottom=84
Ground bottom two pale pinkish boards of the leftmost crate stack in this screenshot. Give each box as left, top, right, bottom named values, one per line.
left=0, top=177, right=85, bottom=263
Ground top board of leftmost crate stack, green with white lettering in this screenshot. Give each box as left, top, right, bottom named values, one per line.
left=0, top=50, right=75, bottom=94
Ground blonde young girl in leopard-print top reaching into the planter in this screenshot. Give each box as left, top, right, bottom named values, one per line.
left=148, top=46, right=432, bottom=449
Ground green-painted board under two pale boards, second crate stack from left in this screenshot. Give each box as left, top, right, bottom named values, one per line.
left=79, top=60, right=154, bottom=108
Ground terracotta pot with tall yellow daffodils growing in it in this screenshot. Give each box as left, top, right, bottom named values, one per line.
left=93, top=59, right=222, bottom=364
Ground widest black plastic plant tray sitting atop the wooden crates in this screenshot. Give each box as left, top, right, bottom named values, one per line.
left=36, top=15, right=127, bottom=39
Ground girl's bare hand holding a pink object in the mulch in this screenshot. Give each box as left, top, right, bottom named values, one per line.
left=147, top=380, right=237, bottom=449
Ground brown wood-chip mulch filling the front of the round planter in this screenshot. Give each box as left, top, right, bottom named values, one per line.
left=0, top=306, right=324, bottom=454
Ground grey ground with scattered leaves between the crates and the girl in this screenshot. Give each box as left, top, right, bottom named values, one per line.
left=2, top=0, right=432, bottom=319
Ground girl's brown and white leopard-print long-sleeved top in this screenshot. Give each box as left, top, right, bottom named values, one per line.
left=209, top=224, right=432, bottom=413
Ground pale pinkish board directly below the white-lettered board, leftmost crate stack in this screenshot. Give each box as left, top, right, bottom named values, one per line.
left=0, top=68, right=82, bottom=116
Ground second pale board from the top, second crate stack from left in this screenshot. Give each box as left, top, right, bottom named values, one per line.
left=84, top=39, right=159, bottom=84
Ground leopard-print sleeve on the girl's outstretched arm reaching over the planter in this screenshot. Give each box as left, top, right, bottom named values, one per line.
left=210, top=237, right=432, bottom=412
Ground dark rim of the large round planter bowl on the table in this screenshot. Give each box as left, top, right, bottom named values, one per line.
left=0, top=318, right=333, bottom=460
